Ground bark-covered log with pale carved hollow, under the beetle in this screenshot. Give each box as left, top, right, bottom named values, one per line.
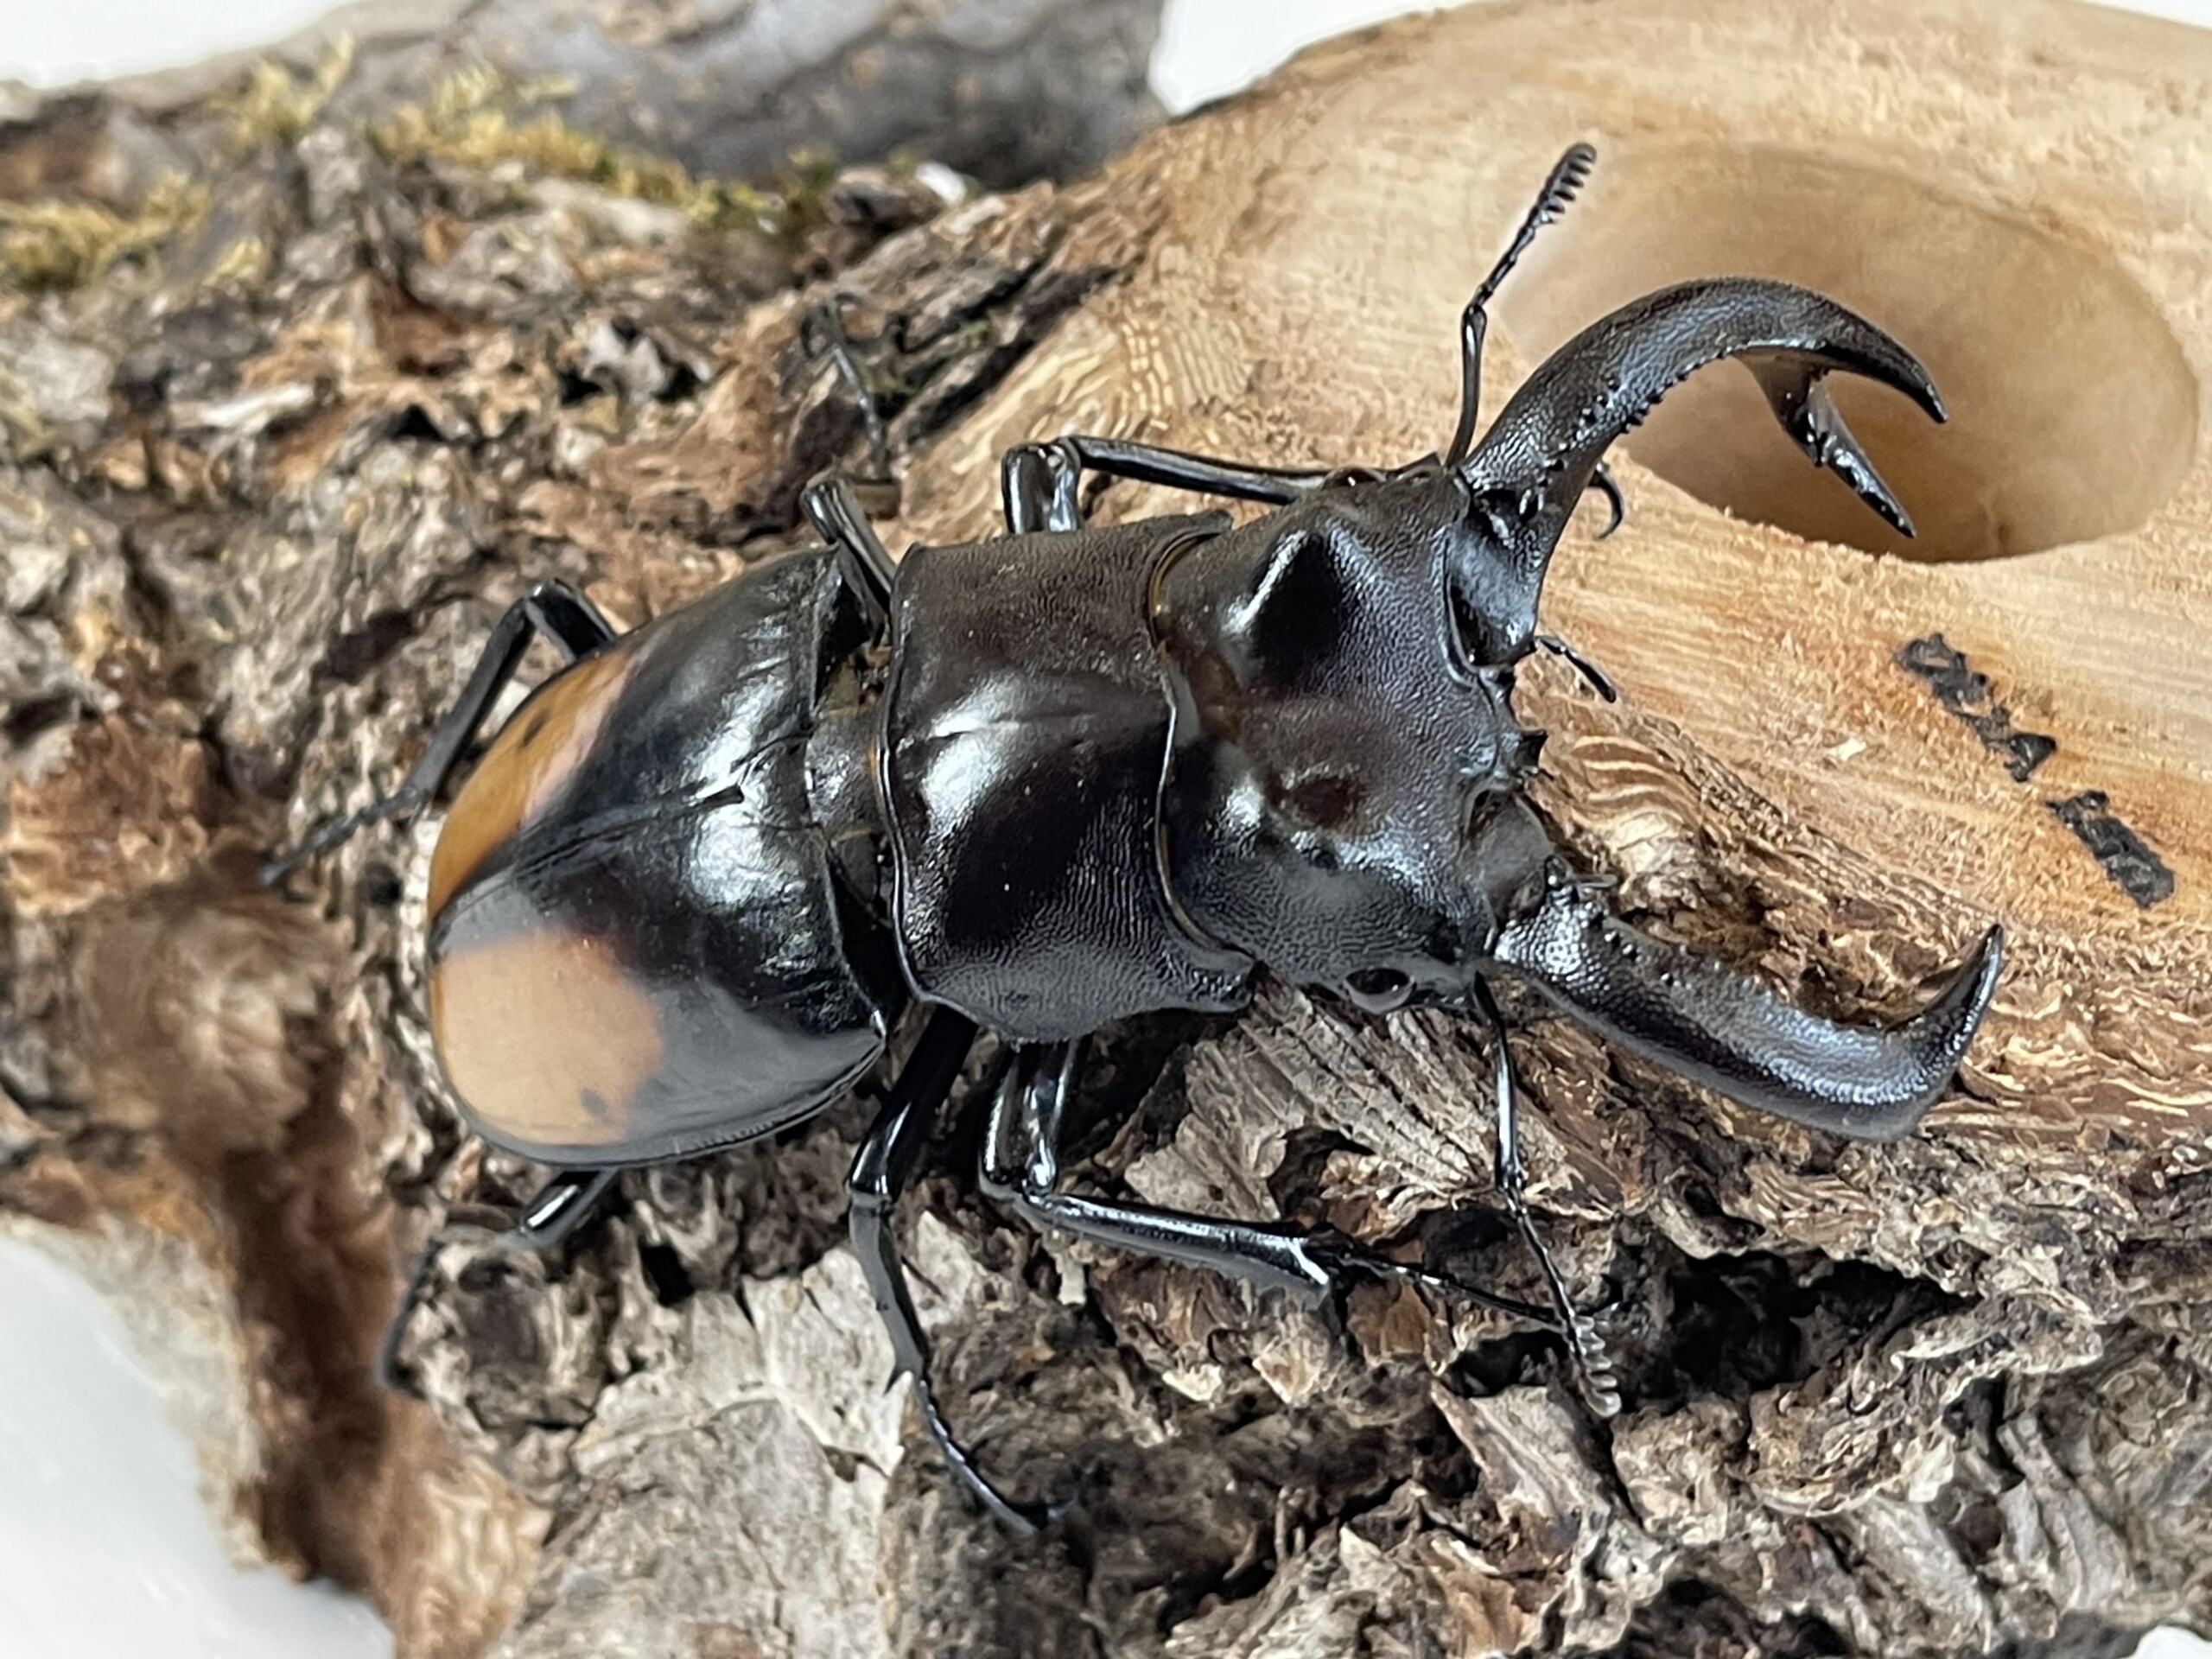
left=0, top=0, right=2212, bottom=1659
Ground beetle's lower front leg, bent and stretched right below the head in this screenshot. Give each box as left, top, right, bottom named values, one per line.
left=982, top=1042, right=1561, bottom=1330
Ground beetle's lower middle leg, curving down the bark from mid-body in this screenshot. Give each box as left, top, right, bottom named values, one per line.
left=845, top=1008, right=1051, bottom=1533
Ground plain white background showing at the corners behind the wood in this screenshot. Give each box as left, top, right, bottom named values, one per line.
left=0, top=0, right=2212, bottom=1659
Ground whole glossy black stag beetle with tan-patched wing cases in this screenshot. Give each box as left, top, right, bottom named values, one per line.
left=270, top=146, right=2002, bottom=1529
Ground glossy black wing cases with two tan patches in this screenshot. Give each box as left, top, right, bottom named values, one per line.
left=429, top=553, right=902, bottom=1166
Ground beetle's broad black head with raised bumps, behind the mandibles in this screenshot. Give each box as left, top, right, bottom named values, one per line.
left=1153, top=477, right=1548, bottom=1008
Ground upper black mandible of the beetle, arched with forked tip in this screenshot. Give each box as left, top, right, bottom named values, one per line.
left=1455, top=276, right=1947, bottom=659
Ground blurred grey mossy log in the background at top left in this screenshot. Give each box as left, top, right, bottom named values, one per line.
left=0, top=0, right=1159, bottom=186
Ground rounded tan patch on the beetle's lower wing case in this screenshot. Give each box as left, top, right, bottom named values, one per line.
left=429, top=927, right=666, bottom=1148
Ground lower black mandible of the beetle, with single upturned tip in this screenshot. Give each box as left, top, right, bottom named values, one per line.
left=1491, top=865, right=2004, bottom=1141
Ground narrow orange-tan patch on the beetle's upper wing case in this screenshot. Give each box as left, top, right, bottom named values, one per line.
left=429, top=648, right=637, bottom=916
